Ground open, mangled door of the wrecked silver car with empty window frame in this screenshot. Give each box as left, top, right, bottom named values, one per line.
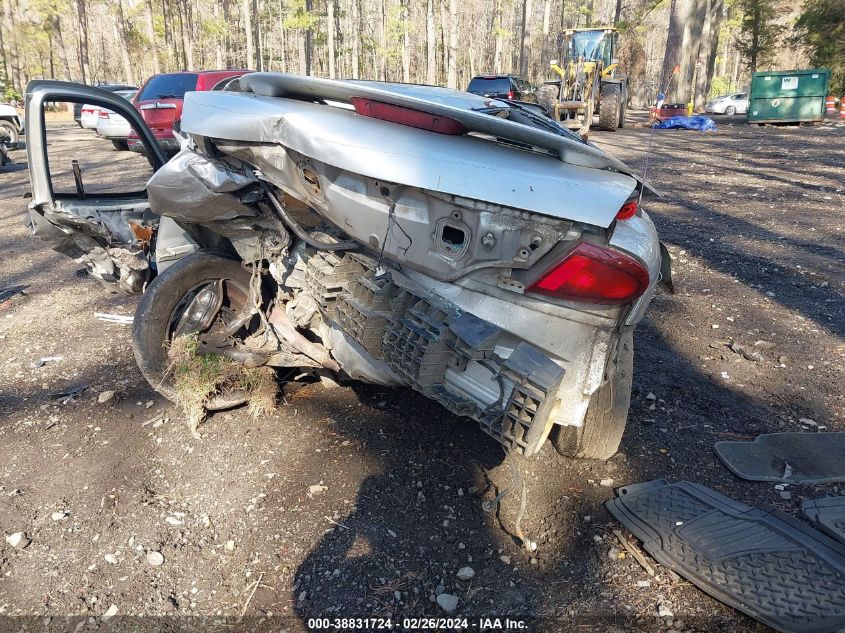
left=26, top=81, right=167, bottom=292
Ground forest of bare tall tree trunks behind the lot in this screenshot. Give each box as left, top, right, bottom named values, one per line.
left=0, top=0, right=845, bottom=108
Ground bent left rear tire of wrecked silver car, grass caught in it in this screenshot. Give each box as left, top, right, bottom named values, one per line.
left=132, top=251, right=250, bottom=411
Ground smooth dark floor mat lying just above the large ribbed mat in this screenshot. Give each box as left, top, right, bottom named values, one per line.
left=714, top=432, right=845, bottom=484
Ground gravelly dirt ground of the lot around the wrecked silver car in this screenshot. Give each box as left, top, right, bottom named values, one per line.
left=0, top=117, right=845, bottom=631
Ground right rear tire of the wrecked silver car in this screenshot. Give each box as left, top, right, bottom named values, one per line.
left=551, top=332, right=634, bottom=459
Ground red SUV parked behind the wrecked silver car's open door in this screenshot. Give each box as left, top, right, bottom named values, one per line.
left=127, top=70, right=249, bottom=154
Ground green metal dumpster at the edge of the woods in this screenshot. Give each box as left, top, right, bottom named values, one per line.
left=748, top=68, right=830, bottom=123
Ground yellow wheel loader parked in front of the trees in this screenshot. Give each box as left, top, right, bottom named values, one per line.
left=537, top=27, right=628, bottom=137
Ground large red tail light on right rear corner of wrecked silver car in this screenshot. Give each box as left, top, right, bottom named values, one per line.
left=527, top=242, right=649, bottom=305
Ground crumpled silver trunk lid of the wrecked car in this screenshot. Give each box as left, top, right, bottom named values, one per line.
left=182, top=73, right=637, bottom=227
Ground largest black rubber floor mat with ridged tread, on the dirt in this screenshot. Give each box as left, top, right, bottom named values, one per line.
left=607, top=480, right=845, bottom=633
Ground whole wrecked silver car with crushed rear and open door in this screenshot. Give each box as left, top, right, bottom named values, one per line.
left=27, top=73, right=669, bottom=458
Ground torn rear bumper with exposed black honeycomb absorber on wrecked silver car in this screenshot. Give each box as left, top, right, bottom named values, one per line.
left=288, top=241, right=648, bottom=455
